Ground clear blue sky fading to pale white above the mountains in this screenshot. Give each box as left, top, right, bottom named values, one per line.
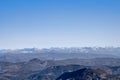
left=0, top=0, right=120, bottom=49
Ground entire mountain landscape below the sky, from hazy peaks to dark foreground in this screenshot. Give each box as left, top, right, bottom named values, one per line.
left=0, top=47, right=120, bottom=80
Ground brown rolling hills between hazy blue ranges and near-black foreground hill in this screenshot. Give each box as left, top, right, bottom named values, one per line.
left=0, top=58, right=120, bottom=80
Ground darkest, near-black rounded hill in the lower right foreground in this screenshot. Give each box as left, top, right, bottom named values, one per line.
left=56, top=68, right=120, bottom=80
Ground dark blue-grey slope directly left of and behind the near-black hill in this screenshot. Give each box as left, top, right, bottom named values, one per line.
left=28, top=65, right=85, bottom=80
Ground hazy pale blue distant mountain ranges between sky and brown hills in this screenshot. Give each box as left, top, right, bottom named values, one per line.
left=0, top=47, right=120, bottom=62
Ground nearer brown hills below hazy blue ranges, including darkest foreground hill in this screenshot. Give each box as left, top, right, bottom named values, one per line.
left=0, top=59, right=120, bottom=80
